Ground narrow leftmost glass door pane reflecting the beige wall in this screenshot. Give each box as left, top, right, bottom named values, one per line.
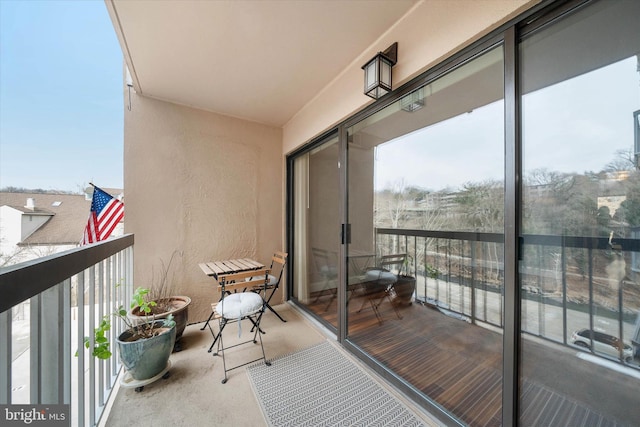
left=292, top=136, right=340, bottom=328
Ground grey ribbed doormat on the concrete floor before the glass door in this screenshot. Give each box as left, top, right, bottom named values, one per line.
left=247, top=341, right=425, bottom=427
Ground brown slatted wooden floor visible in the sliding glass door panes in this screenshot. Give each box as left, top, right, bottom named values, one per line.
left=310, top=295, right=640, bottom=426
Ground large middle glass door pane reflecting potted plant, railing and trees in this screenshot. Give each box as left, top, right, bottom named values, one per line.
left=346, top=46, right=505, bottom=426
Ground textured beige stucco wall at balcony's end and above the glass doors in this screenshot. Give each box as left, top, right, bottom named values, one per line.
left=124, top=0, right=539, bottom=323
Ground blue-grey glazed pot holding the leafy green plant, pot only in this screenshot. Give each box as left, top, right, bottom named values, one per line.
left=116, top=320, right=176, bottom=381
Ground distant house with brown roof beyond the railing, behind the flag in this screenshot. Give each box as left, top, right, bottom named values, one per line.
left=0, top=189, right=124, bottom=267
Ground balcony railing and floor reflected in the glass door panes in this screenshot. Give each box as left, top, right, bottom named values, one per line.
left=310, top=229, right=640, bottom=426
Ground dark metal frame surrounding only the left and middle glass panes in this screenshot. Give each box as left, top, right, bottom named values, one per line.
left=286, top=31, right=519, bottom=425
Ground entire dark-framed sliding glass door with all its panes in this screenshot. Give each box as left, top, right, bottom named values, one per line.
left=288, top=0, right=640, bottom=426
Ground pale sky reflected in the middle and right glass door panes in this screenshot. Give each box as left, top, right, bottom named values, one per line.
left=375, top=55, right=640, bottom=191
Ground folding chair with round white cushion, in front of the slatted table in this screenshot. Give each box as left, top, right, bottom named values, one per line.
left=211, top=268, right=271, bottom=384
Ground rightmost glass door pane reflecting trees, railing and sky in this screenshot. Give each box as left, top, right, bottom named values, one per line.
left=520, top=1, right=640, bottom=426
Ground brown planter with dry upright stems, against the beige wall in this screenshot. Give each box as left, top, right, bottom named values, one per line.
left=127, top=251, right=191, bottom=351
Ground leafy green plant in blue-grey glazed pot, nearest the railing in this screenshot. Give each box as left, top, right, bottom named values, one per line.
left=76, top=288, right=176, bottom=389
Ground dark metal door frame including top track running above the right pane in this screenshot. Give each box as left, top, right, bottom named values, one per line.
left=286, top=0, right=591, bottom=425
